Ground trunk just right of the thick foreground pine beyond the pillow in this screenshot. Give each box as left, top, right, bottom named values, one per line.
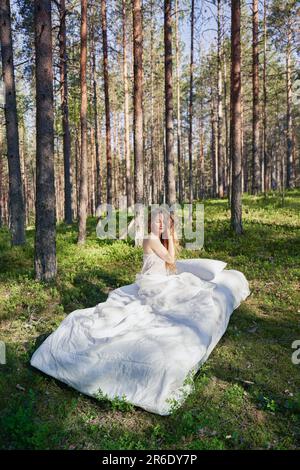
left=252, top=0, right=261, bottom=194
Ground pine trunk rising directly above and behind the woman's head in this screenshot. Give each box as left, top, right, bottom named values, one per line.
left=164, top=0, right=176, bottom=206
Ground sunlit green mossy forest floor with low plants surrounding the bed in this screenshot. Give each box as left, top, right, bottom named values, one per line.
left=0, top=190, right=300, bottom=450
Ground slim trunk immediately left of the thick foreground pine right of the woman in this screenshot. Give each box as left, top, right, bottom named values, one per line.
left=217, top=0, right=224, bottom=197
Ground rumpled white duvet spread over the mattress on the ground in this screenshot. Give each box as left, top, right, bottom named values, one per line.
left=30, top=270, right=250, bottom=415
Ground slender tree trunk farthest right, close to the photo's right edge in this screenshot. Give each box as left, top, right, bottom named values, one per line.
left=286, top=23, right=295, bottom=188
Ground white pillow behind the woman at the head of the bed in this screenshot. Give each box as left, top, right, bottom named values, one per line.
left=176, top=258, right=227, bottom=281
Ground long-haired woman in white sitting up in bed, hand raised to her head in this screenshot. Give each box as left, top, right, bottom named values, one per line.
left=141, top=208, right=179, bottom=275
